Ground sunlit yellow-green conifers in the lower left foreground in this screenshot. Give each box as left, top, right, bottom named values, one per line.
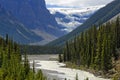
left=0, top=35, right=46, bottom=80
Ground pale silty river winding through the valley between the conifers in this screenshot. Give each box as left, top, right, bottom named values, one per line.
left=28, top=55, right=110, bottom=80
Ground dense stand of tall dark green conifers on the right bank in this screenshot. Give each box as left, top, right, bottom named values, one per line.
left=59, top=18, right=120, bottom=72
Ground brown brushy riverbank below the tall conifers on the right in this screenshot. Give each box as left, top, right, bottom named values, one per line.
left=65, top=59, right=120, bottom=80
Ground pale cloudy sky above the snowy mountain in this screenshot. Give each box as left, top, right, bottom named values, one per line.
left=45, top=0, right=113, bottom=8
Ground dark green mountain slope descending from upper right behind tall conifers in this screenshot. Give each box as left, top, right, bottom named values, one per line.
left=47, top=0, right=120, bottom=46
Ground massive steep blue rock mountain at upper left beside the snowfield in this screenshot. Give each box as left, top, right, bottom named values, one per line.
left=0, top=0, right=65, bottom=44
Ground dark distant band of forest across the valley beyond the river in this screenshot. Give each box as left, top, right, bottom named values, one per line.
left=20, top=45, right=61, bottom=55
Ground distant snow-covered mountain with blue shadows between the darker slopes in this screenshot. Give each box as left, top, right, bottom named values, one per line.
left=48, top=5, right=104, bottom=33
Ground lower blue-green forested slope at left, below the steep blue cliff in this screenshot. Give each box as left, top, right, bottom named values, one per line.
left=0, top=6, right=43, bottom=44
